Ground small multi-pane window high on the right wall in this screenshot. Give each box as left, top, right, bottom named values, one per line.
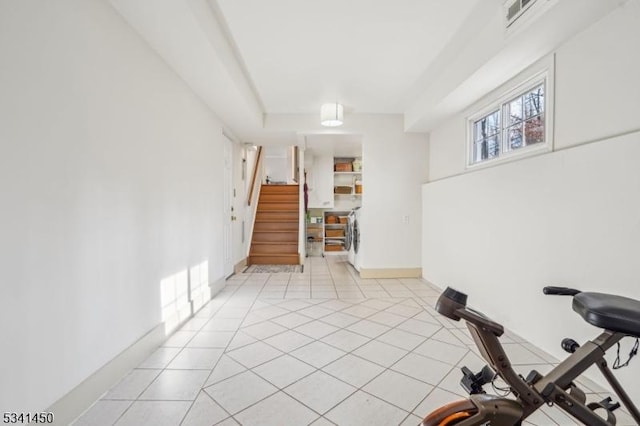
left=469, top=80, right=547, bottom=165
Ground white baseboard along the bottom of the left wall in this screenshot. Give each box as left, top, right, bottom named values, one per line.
left=52, top=277, right=226, bottom=425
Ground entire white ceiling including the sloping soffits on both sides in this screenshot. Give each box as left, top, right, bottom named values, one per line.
left=110, top=0, right=625, bottom=145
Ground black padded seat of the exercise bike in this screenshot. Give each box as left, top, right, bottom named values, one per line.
left=573, top=292, right=640, bottom=337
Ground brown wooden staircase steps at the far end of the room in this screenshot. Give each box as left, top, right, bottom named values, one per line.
left=247, top=185, right=300, bottom=265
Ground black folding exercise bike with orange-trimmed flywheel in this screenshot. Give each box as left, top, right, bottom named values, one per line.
left=421, top=287, right=640, bottom=426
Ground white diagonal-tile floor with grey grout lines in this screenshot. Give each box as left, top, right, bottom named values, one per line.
left=74, top=256, right=633, bottom=426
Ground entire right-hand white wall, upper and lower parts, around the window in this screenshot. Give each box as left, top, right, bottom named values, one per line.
left=423, top=0, right=640, bottom=399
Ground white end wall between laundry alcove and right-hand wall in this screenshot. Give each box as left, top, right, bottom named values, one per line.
left=361, top=116, right=429, bottom=269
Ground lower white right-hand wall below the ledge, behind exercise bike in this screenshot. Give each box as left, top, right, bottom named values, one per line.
left=423, top=133, right=640, bottom=392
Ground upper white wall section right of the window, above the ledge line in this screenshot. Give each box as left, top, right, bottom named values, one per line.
left=555, top=0, right=640, bottom=149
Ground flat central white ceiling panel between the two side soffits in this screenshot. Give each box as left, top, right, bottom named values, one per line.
left=212, top=0, right=486, bottom=114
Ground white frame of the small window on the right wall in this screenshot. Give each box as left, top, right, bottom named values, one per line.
left=465, top=59, right=554, bottom=170
